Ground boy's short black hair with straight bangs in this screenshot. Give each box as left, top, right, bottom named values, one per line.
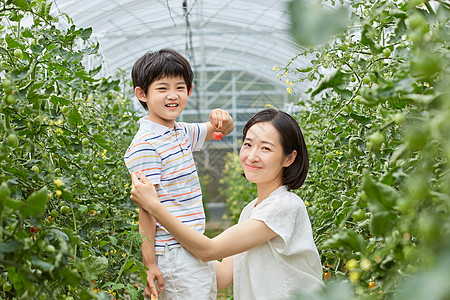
left=131, top=49, right=194, bottom=110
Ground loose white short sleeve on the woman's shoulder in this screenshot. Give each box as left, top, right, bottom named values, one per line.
left=250, top=193, right=311, bottom=254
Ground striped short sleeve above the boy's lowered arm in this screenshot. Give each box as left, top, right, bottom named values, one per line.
left=124, top=140, right=161, bottom=184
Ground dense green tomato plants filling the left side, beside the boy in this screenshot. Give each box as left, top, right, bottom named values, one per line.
left=0, top=0, right=145, bottom=299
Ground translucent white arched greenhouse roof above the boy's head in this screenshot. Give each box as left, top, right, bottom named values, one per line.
left=52, top=0, right=310, bottom=84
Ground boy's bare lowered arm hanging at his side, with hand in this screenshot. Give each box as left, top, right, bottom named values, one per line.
left=139, top=208, right=164, bottom=298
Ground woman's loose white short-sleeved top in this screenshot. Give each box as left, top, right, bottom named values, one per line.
left=233, top=186, right=324, bottom=300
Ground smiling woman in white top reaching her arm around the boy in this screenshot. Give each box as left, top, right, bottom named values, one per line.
left=131, top=109, right=323, bottom=300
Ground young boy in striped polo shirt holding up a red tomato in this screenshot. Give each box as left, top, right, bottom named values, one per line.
left=124, top=49, right=234, bottom=300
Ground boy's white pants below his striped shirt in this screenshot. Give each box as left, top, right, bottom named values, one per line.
left=156, top=246, right=217, bottom=300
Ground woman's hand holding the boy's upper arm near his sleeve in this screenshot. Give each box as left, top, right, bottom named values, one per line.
left=130, top=171, right=161, bottom=214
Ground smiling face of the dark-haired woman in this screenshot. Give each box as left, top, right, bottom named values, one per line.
left=239, top=122, right=293, bottom=186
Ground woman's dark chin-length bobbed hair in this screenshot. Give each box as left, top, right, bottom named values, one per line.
left=243, top=108, right=309, bottom=190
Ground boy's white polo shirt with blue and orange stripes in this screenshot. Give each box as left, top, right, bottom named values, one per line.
left=124, top=117, right=207, bottom=255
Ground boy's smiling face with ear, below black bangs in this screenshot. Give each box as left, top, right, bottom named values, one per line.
left=135, top=76, right=191, bottom=127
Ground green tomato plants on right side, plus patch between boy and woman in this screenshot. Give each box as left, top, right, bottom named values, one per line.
left=223, top=0, right=450, bottom=300
